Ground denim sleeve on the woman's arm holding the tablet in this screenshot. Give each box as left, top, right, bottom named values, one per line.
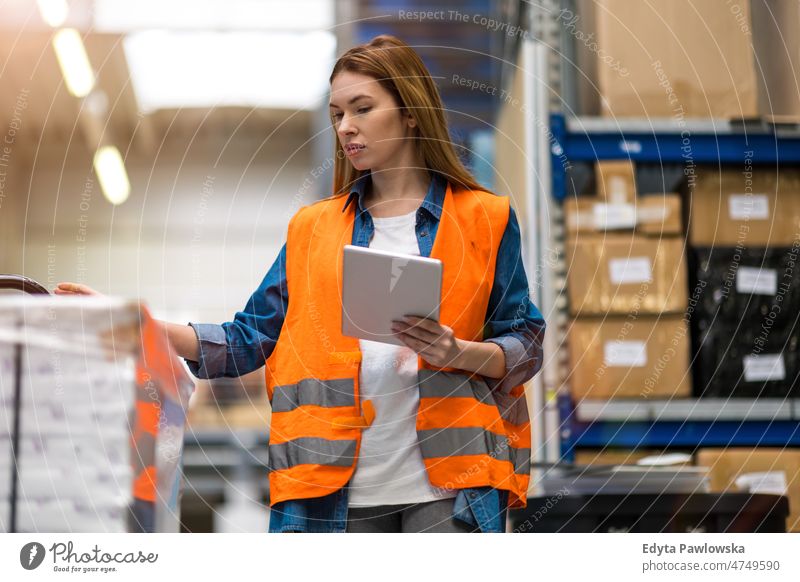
left=484, top=208, right=546, bottom=392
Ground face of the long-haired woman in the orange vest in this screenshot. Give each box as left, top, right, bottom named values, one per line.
left=330, top=71, right=416, bottom=171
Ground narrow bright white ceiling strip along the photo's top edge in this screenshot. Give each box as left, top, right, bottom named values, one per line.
left=93, top=0, right=334, bottom=33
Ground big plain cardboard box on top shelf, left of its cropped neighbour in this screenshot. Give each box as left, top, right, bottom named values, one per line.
left=576, top=0, right=756, bottom=118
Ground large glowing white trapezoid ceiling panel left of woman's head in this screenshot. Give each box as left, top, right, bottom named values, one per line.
left=123, top=30, right=336, bottom=112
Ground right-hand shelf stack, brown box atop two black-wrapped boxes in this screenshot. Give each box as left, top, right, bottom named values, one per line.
left=690, top=167, right=800, bottom=398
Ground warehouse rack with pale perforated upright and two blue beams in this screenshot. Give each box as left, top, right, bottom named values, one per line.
left=520, top=0, right=800, bottom=461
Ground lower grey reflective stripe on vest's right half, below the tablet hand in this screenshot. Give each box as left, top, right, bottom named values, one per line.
left=417, top=427, right=531, bottom=474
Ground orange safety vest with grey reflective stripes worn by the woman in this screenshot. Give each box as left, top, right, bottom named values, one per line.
left=266, top=185, right=531, bottom=508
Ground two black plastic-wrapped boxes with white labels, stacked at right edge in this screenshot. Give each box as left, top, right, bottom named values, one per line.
left=689, top=247, right=800, bottom=398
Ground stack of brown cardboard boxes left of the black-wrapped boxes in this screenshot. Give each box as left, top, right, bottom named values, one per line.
left=565, top=161, right=691, bottom=401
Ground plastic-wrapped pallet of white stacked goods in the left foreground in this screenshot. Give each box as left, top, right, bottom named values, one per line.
left=0, top=296, right=192, bottom=532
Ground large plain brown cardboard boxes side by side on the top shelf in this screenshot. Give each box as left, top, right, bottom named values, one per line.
left=576, top=0, right=800, bottom=121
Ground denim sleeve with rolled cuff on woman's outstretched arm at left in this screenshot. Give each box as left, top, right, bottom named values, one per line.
left=186, top=245, right=289, bottom=379
